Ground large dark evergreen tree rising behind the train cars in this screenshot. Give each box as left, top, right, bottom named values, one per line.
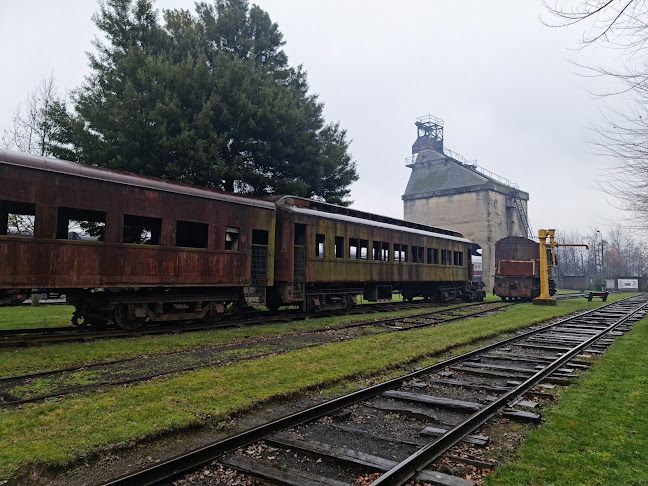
left=54, top=0, right=358, bottom=204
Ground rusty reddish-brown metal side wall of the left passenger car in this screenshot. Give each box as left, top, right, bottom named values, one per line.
left=0, top=152, right=275, bottom=288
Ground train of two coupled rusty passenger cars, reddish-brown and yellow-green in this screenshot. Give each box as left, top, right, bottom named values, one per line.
left=0, top=150, right=484, bottom=329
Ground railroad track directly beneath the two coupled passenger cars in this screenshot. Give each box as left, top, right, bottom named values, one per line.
left=0, top=300, right=479, bottom=347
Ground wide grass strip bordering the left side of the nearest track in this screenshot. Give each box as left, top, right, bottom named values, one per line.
left=0, top=294, right=636, bottom=478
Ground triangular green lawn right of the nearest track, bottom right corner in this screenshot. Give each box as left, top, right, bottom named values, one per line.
left=484, top=318, right=648, bottom=486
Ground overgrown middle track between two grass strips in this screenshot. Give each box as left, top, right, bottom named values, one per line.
left=0, top=302, right=511, bottom=408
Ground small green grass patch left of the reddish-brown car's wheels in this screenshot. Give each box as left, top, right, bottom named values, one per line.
left=0, top=305, right=74, bottom=329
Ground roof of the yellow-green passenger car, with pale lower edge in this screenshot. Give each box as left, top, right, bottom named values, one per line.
left=277, top=196, right=471, bottom=243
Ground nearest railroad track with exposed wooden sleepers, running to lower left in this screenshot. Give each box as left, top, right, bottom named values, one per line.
left=97, top=294, right=648, bottom=486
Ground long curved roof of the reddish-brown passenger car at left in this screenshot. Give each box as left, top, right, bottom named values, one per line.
left=0, top=149, right=276, bottom=210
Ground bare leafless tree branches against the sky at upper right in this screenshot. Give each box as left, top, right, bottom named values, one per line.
left=542, top=0, right=648, bottom=232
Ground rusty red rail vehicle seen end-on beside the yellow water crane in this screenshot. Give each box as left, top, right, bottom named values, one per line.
left=493, top=236, right=556, bottom=300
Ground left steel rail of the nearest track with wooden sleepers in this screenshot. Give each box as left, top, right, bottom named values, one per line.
left=97, top=301, right=622, bottom=486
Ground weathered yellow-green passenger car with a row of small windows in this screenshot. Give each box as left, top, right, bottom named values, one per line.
left=269, top=196, right=484, bottom=310
